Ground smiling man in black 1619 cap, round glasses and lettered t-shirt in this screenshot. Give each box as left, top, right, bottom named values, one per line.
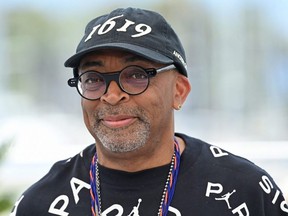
left=11, top=8, right=288, bottom=216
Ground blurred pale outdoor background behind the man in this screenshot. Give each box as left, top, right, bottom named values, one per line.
left=0, top=0, right=288, bottom=215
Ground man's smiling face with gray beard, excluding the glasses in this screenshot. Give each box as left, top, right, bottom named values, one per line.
left=79, top=50, right=178, bottom=152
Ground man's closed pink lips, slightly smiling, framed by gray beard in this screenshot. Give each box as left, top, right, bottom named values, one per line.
left=101, top=115, right=137, bottom=128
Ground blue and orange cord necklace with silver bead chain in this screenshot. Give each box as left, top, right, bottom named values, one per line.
left=89, top=138, right=180, bottom=216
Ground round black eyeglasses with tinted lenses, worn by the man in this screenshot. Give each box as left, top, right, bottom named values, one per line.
left=68, top=64, right=176, bottom=100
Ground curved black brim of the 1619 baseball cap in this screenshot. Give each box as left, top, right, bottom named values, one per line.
left=64, top=43, right=173, bottom=68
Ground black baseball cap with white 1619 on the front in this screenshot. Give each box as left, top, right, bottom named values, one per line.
left=64, top=8, right=187, bottom=76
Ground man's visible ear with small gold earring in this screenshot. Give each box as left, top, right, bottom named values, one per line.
left=173, top=74, right=191, bottom=110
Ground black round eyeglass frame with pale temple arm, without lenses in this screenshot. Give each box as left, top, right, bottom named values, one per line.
left=68, top=64, right=176, bottom=101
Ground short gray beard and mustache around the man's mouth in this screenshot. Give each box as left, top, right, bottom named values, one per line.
left=93, top=107, right=150, bottom=153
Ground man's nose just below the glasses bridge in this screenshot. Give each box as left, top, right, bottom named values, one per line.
left=100, top=81, right=129, bottom=105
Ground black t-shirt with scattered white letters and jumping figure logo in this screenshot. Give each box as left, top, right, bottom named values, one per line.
left=11, top=134, right=288, bottom=216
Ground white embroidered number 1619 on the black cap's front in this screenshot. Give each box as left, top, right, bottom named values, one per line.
left=85, top=14, right=152, bottom=42
